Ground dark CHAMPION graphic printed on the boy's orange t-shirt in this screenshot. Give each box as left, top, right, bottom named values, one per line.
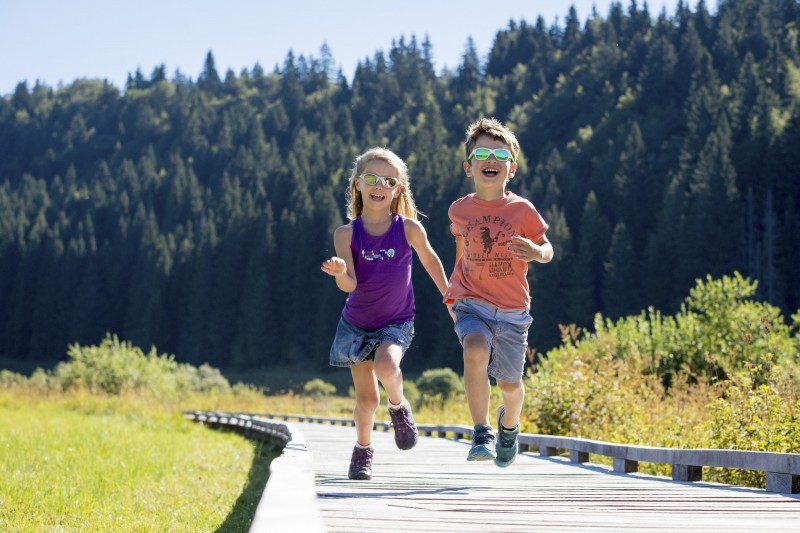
left=464, top=216, right=516, bottom=280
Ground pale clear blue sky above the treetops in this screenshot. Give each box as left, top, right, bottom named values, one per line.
left=0, top=0, right=717, bottom=95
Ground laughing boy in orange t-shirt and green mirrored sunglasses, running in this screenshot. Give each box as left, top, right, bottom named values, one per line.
left=445, top=118, right=553, bottom=467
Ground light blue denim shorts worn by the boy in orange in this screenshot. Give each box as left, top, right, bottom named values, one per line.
left=453, top=298, right=533, bottom=383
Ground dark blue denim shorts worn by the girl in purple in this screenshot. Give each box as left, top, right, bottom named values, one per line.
left=330, top=317, right=414, bottom=366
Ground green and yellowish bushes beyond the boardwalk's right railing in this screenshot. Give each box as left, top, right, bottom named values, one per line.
left=521, top=275, right=800, bottom=486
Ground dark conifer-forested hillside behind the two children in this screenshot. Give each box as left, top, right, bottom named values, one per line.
left=0, top=0, right=800, bottom=369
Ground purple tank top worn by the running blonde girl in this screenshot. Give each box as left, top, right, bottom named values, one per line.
left=342, top=214, right=414, bottom=331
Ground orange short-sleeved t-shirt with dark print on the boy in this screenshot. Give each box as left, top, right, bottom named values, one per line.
left=444, top=191, right=548, bottom=310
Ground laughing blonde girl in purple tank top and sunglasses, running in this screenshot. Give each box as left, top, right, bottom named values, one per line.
left=322, top=148, right=454, bottom=479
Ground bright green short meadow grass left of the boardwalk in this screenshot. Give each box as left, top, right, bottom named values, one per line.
left=0, top=391, right=275, bottom=532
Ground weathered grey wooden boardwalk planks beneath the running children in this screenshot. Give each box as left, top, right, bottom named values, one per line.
left=294, top=423, right=800, bottom=533
